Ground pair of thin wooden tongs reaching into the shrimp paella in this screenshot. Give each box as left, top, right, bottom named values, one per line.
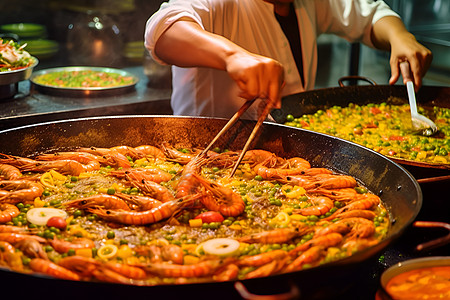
left=200, top=98, right=272, bottom=177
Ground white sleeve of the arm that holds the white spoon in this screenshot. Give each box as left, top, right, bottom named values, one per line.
left=316, top=0, right=400, bottom=47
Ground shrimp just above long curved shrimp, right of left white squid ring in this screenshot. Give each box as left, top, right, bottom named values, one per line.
left=64, top=194, right=130, bottom=210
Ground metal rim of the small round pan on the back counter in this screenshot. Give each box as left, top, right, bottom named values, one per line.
left=30, top=66, right=139, bottom=97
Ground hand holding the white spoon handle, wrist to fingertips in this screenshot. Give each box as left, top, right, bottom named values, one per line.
left=389, top=33, right=433, bottom=91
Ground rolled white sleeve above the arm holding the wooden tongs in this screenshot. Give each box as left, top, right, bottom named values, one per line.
left=144, top=0, right=209, bottom=64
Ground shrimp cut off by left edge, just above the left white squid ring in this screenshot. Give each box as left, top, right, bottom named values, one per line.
left=0, top=180, right=44, bottom=204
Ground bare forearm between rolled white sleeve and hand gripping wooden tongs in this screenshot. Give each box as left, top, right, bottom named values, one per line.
left=155, top=20, right=244, bottom=70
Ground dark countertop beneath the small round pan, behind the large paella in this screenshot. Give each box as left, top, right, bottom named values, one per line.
left=0, top=66, right=172, bottom=130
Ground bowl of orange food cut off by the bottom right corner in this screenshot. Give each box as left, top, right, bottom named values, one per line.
left=379, top=256, right=450, bottom=300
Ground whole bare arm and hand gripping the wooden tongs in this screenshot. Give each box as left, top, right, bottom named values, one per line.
left=154, top=19, right=284, bottom=108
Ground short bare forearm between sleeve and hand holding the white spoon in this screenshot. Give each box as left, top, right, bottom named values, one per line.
left=371, top=16, right=415, bottom=51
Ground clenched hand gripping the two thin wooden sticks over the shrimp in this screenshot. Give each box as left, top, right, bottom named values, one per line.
left=226, top=51, right=285, bottom=108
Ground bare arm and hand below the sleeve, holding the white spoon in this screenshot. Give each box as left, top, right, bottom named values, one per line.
left=371, top=16, right=433, bottom=90
